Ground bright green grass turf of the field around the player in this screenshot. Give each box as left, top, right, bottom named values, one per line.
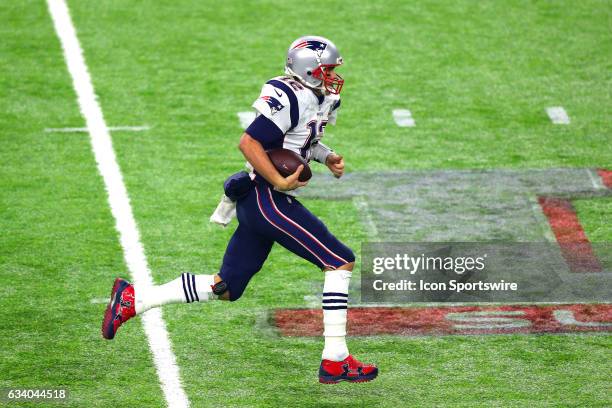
left=0, top=1, right=612, bottom=407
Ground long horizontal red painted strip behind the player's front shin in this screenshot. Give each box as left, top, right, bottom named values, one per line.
left=274, top=304, right=612, bottom=337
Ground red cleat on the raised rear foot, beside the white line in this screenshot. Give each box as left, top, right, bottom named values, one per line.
left=102, top=278, right=136, bottom=340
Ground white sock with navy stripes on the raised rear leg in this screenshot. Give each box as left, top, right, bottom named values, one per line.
left=134, top=273, right=216, bottom=314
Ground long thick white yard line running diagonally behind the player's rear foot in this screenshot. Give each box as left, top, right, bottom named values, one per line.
left=47, top=0, right=189, bottom=407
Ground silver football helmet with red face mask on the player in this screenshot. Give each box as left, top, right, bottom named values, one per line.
left=285, top=35, right=344, bottom=94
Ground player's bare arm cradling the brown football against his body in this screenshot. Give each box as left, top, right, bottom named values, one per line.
left=238, top=132, right=307, bottom=191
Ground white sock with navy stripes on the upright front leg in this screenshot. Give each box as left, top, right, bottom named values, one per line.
left=322, top=269, right=352, bottom=361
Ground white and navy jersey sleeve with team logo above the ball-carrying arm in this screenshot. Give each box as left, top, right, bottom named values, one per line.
left=246, top=84, right=292, bottom=145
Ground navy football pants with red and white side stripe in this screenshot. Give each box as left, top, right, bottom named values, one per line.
left=219, top=181, right=355, bottom=301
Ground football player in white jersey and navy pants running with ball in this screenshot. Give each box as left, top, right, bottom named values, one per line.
left=102, top=36, right=378, bottom=384
